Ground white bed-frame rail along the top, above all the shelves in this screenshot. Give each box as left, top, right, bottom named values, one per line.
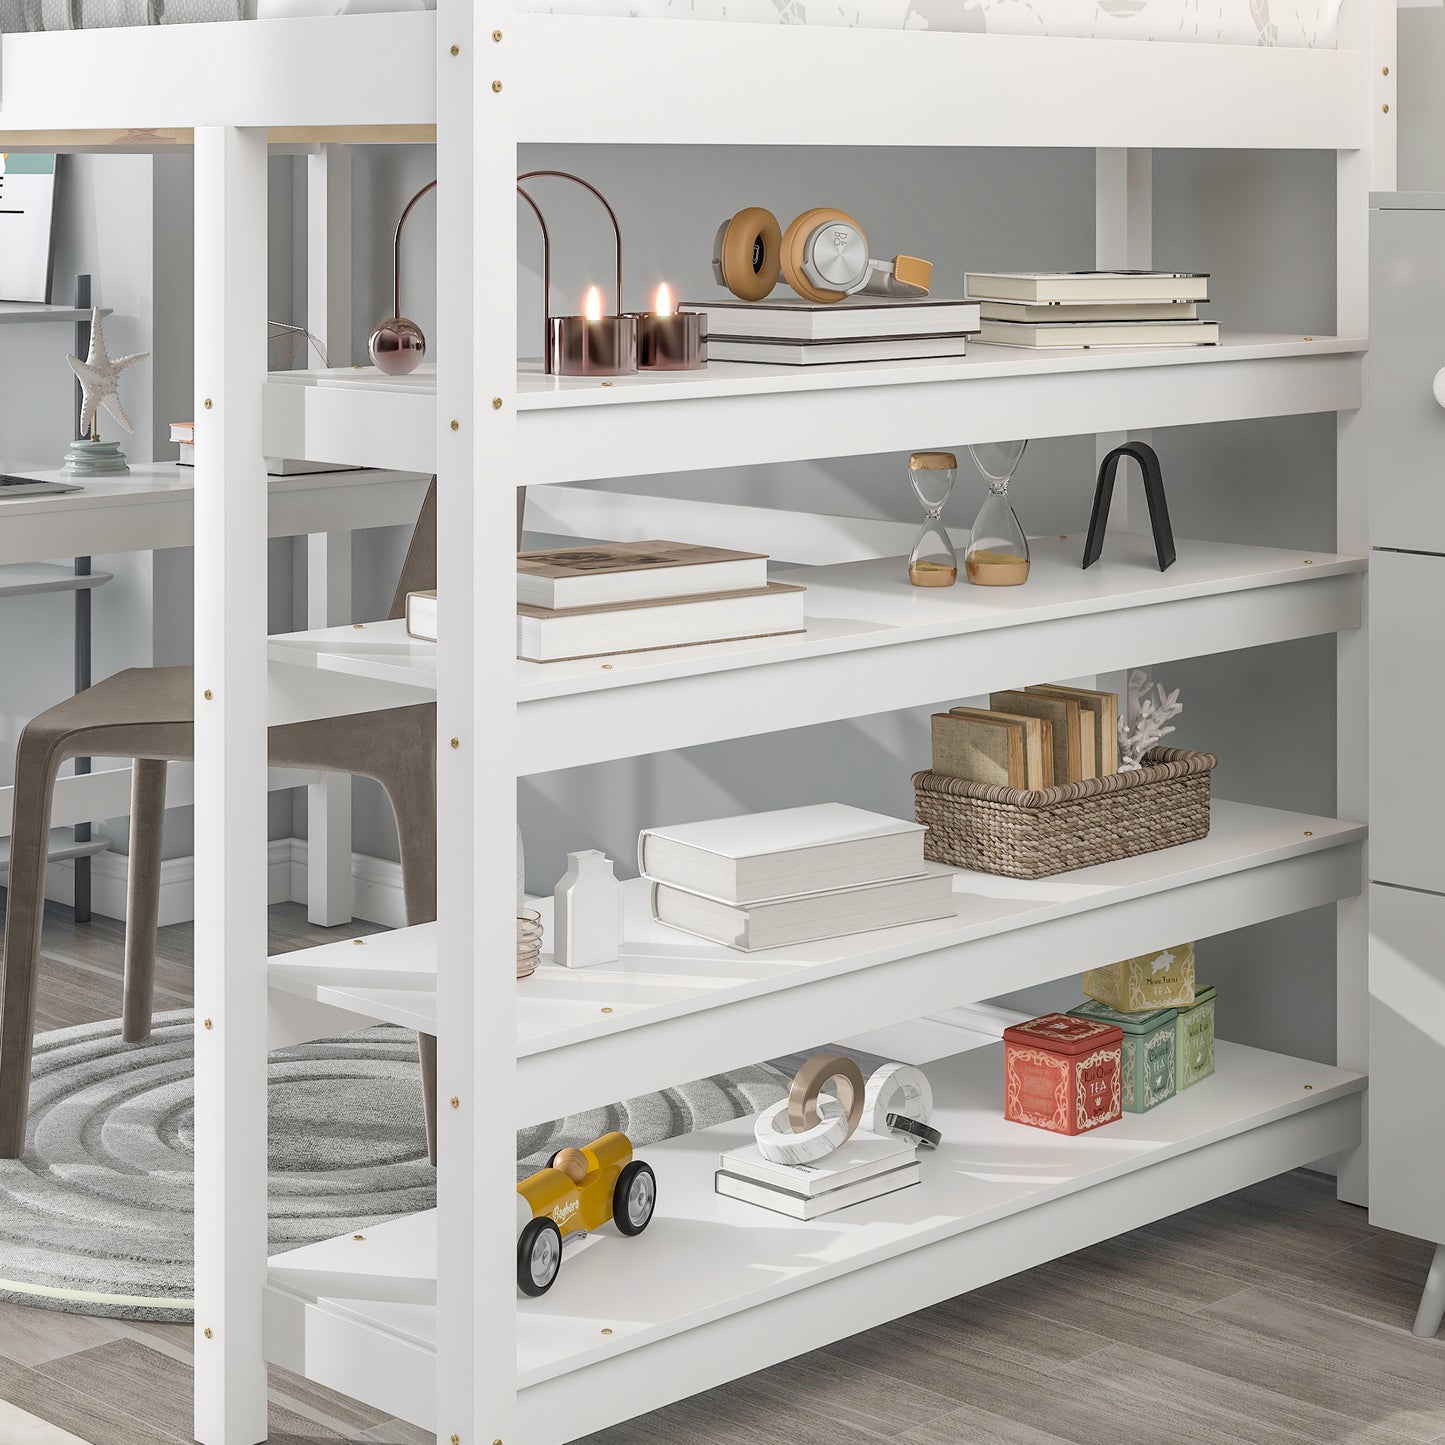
left=0, top=13, right=1364, bottom=150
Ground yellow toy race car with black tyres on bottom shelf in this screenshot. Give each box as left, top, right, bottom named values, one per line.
left=517, top=1133, right=657, bottom=1296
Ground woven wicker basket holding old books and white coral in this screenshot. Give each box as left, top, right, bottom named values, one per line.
left=913, top=747, right=1218, bottom=879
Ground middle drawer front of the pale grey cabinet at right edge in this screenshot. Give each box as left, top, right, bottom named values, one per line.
left=1370, top=546, right=1445, bottom=895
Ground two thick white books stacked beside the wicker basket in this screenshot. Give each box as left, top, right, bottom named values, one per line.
left=637, top=803, right=955, bottom=952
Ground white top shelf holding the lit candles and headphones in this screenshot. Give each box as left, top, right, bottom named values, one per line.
left=264, top=333, right=1364, bottom=486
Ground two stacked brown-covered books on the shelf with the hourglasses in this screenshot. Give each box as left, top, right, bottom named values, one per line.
left=406, top=542, right=806, bottom=662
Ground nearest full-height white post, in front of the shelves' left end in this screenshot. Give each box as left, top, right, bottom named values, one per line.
left=436, top=0, right=523, bottom=1445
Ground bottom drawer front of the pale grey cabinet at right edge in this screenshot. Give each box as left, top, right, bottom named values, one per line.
left=1370, top=884, right=1445, bottom=1243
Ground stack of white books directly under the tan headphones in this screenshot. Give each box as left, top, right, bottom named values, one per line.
left=682, top=296, right=978, bottom=366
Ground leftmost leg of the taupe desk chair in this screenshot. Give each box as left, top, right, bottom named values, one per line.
left=0, top=730, right=62, bottom=1159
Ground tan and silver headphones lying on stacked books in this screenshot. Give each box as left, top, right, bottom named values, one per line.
left=712, top=205, right=933, bottom=303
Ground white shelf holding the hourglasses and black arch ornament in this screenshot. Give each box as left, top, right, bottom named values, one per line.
left=270, top=533, right=1366, bottom=775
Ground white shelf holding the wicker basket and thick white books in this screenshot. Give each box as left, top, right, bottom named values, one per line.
left=270, top=802, right=1366, bottom=1127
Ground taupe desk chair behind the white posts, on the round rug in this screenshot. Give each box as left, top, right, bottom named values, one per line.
left=0, top=478, right=436, bottom=1162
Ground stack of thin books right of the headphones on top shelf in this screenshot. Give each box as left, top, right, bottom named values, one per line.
left=964, top=270, right=1220, bottom=350
